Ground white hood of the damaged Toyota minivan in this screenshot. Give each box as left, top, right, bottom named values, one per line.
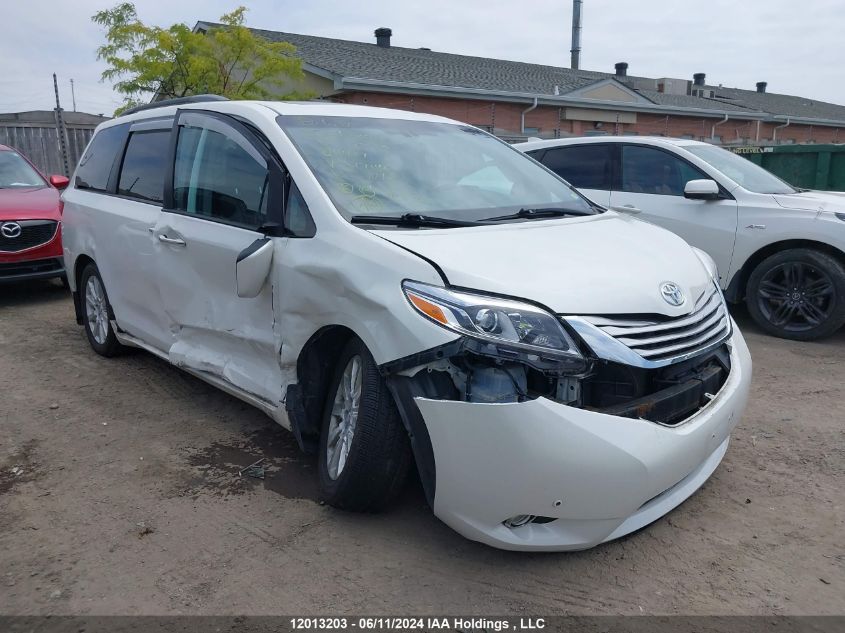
left=374, top=211, right=713, bottom=316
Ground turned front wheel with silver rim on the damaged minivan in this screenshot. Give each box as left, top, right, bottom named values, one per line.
left=319, top=338, right=411, bottom=512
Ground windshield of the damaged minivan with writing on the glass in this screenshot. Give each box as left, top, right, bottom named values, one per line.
left=278, top=116, right=594, bottom=222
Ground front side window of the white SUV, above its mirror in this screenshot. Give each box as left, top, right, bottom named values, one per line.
left=622, top=145, right=708, bottom=196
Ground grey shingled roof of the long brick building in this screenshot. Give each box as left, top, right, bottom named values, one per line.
left=196, top=22, right=845, bottom=125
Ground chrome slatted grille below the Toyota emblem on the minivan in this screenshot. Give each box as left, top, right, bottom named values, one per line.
left=581, top=287, right=731, bottom=361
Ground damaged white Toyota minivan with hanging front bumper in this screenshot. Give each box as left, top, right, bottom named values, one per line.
left=62, top=97, right=751, bottom=550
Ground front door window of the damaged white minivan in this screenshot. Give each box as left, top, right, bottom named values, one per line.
left=173, top=126, right=269, bottom=227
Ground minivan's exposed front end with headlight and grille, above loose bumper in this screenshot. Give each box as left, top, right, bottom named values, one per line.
left=381, top=282, right=731, bottom=502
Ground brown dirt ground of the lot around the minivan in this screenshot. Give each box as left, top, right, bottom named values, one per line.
left=0, top=283, right=845, bottom=615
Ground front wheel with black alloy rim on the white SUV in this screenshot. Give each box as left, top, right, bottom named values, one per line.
left=745, top=248, right=845, bottom=341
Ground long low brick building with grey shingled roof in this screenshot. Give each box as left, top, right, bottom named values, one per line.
left=195, top=22, right=845, bottom=145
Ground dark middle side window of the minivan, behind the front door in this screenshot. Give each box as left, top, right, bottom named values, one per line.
left=117, top=130, right=170, bottom=204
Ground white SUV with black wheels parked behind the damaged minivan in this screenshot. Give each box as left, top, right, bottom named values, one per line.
left=517, top=136, right=845, bottom=341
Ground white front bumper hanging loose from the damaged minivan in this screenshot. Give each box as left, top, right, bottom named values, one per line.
left=416, top=329, right=751, bottom=551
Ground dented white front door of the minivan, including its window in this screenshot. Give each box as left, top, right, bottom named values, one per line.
left=153, top=110, right=284, bottom=405
